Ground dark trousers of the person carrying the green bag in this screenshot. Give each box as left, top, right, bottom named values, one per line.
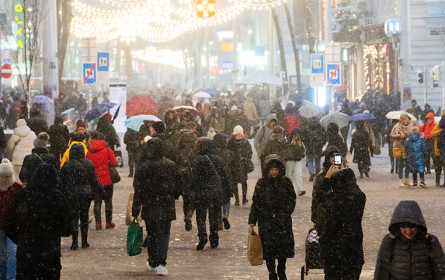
left=145, top=221, right=172, bottom=267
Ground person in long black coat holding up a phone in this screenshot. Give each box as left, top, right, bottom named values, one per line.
left=316, top=165, right=366, bottom=280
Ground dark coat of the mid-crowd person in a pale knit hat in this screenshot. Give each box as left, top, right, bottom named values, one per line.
left=227, top=137, right=253, bottom=183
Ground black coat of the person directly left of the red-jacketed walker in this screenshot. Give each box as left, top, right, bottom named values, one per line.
left=60, top=143, right=105, bottom=200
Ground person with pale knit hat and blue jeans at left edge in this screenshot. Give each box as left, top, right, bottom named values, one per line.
left=0, top=158, right=23, bottom=279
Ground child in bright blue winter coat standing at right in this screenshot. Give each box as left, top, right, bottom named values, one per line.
left=405, top=127, right=426, bottom=188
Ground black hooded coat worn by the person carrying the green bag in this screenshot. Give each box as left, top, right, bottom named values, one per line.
left=132, top=138, right=180, bottom=222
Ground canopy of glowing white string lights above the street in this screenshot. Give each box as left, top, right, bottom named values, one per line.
left=71, top=0, right=286, bottom=43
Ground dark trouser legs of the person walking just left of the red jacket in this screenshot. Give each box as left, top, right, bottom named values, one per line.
left=70, top=198, right=91, bottom=240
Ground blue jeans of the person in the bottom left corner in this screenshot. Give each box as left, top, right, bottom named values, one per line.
left=0, top=231, right=17, bottom=280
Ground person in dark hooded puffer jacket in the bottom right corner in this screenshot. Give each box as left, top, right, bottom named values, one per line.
left=374, top=200, right=445, bottom=280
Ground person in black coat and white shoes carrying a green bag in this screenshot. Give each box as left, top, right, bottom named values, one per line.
left=132, top=138, right=180, bottom=275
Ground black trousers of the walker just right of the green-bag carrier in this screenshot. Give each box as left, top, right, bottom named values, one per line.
left=195, top=200, right=222, bottom=245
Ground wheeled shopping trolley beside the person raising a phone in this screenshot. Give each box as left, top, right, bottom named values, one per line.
left=301, top=229, right=324, bottom=280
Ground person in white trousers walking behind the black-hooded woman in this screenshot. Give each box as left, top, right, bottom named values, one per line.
left=285, top=128, right=306, bottom=196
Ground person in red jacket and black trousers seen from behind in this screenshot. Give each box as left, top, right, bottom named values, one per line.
left=86, top=131, right=118, bottom=230
